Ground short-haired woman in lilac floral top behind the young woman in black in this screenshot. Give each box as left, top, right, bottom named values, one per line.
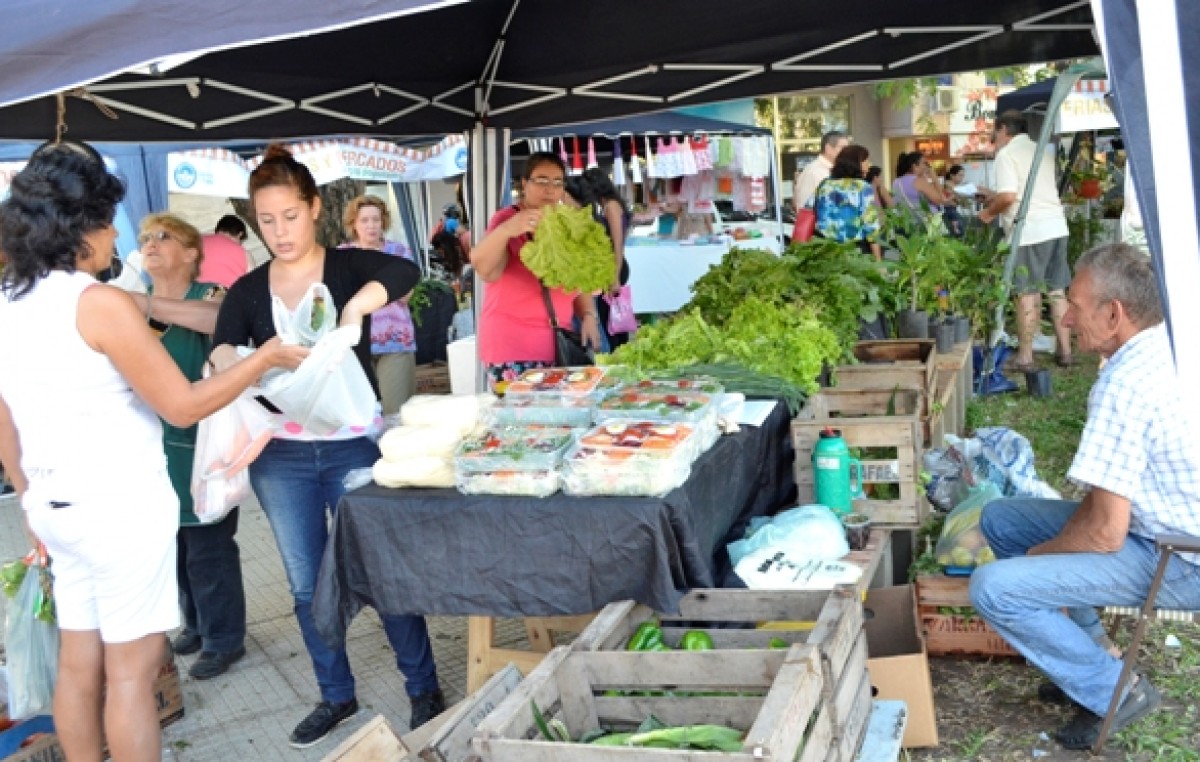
left=340, top=196, right=416, bottom=415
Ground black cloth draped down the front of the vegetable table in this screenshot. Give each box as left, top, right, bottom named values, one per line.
left=313, top=402, right=796, bottom=643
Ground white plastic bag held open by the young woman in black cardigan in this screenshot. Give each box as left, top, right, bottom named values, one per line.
left=258, top=325, right=376, bottom=437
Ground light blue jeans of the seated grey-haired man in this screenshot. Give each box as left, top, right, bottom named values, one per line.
left=971, top=498, right=1200, bottom=716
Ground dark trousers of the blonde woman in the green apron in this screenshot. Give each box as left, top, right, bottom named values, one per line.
left=175, top=508, right=246, bottom=654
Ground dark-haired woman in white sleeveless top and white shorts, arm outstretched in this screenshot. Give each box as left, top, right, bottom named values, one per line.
left=0, top=143, right=307, bottom=762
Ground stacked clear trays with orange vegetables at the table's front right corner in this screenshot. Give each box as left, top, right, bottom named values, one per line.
left=563, top=421, right=695, bottom=497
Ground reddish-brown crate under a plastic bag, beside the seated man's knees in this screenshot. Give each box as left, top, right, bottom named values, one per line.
left=917, top=575, right=1020, bottom=656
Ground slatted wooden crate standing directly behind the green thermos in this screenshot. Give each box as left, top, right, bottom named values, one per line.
left=792, top=388, right=929, bottom=527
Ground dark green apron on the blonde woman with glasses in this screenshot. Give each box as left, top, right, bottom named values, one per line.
left=149, top=283, right=218, bottom=526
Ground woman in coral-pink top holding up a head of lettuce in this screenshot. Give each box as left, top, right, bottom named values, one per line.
left=470, top=152, right=600, bottom=388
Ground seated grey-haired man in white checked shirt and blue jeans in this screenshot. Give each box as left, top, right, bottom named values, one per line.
left=971, top=244, right=1200, bottom=749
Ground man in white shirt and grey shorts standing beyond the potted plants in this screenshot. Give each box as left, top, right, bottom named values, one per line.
left=979, top=112, right=1075, bottom=371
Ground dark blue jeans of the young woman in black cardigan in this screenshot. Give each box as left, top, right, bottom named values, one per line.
left=250, top=437, right=438, bottom=702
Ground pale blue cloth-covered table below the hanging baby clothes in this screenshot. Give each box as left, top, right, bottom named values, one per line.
left=625, top=238, right=779, bottom=314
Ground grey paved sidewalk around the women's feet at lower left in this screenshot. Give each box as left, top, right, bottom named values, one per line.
left=0, top=497, right=524, bottom=762
